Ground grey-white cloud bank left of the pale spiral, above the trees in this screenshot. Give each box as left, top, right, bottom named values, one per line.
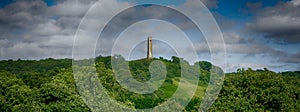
left=0, top=0, right=95, bottom=59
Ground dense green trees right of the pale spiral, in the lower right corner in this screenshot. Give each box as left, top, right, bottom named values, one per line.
left=211, top=69, right=300, bottom=111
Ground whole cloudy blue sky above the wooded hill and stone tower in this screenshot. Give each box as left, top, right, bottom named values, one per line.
left=0, top=0, right=300, bottom=72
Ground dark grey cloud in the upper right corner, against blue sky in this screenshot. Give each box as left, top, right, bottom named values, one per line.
left=247, top=0, right=300, bottom=44
